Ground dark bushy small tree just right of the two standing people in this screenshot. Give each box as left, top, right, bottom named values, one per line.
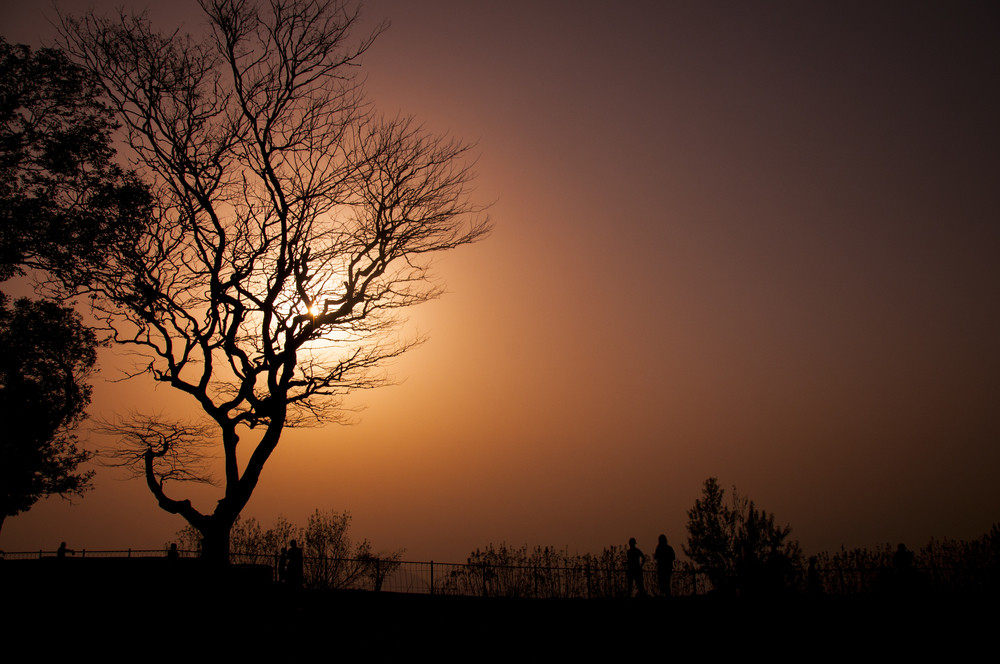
left=684, top=477, right=801, bottom=594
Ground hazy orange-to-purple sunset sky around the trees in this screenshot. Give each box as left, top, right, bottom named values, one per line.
left=0, top=0, right=1000, bottom=561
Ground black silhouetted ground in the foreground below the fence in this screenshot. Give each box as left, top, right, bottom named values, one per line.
left=0, top=559, right=998, bottom=661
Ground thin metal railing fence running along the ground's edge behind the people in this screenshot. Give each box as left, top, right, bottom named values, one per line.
left=0, top=549, right=998, bottom=599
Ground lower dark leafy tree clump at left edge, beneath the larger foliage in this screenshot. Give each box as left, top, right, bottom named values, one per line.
left=0, top=294, right=96, bottom=527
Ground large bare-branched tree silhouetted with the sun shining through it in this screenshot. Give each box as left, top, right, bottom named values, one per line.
left=63, top=0, right=489, bottom=561
